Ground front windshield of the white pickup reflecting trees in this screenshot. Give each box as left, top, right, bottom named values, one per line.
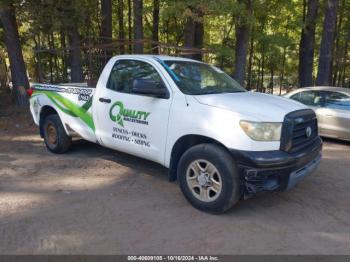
left=160, top=61, right=246, bottom=95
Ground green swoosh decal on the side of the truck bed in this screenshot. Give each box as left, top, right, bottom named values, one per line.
left=32, top=90, right=95, bottom=132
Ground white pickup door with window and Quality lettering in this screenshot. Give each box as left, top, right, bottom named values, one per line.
left=94, top=59, right=172, bottom=164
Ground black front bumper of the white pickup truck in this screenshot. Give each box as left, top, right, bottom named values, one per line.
left=230, top=137, right=322, bottom=198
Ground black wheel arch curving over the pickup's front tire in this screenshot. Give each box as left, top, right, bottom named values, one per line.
left=169, top=135, right=229, bottom=181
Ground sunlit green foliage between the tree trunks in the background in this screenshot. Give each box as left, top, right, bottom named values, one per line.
left=0, top=0, right=350, bottom=88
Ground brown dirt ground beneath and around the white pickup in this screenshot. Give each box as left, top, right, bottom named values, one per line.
left=0, top=96, right=350, bottom=254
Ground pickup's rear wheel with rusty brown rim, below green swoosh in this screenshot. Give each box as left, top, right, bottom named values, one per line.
left=42, top=115, right=72, bottom=154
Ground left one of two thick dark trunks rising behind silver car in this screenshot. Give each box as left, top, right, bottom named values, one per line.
left=299, top=0, right=318, bottom=87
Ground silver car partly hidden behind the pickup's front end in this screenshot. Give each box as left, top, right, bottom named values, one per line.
left=285, top=86, right=350, bottom=140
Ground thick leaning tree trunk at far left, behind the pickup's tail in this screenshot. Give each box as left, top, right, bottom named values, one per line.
left=0, top=5, right=29, bottom=107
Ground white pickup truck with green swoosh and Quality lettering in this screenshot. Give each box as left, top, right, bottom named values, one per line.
left=28, top=55, right=322, bottom=213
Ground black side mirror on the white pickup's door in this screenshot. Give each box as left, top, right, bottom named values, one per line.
left=132, top=79, right=168, bottom=98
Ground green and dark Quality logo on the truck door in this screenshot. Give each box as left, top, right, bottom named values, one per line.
left=109, top=101, right=151, bottom=127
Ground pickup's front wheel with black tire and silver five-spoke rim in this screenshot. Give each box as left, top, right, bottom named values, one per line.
left=177, top=144, right=241, bottom=214
